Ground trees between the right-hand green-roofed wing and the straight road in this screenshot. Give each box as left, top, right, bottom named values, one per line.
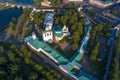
left=88, top=23, right=111, bottom=79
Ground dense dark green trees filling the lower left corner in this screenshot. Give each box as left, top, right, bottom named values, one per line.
left=0, top=43, right=65, bottom=80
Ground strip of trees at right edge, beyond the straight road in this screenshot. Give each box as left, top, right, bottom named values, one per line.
left=108, top=36, right=120, bottom=80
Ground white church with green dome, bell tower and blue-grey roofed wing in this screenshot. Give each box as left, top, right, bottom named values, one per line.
left=42, top=12, right=70, bottom=43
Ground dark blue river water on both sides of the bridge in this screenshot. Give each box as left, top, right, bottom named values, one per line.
left=0, top=0, right=34, bottom=30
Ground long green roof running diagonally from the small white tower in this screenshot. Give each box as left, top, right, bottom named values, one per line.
left=26, top=36, right=68, bottom=64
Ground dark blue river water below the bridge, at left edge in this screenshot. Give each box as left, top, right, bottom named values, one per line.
left=0, top=9, right=22, bottom=30
